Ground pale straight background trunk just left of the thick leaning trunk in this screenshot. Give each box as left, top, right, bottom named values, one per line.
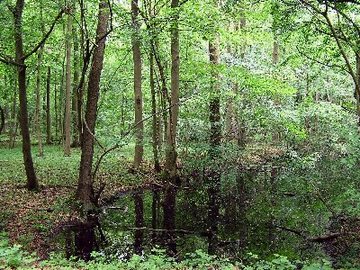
left=64, top=7, right=72, bottom=156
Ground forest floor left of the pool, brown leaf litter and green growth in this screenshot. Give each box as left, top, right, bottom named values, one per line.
left=0, top=146, right=151, bottom=258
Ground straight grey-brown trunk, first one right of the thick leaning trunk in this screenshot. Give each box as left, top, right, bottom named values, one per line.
left=131, top=0, right=144, bottom=169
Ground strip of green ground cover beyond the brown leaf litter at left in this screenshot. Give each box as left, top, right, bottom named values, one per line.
left=0, top=144, right=146, bottom=186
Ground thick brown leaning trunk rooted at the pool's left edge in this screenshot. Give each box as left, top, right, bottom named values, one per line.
left=77, top=0, right=109, bottom=209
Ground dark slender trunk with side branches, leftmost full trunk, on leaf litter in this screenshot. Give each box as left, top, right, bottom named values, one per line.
left=13, top=0, right=39, bottom=190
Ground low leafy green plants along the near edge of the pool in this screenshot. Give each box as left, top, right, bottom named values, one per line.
left=0, top=238, right=338, bottom=270
